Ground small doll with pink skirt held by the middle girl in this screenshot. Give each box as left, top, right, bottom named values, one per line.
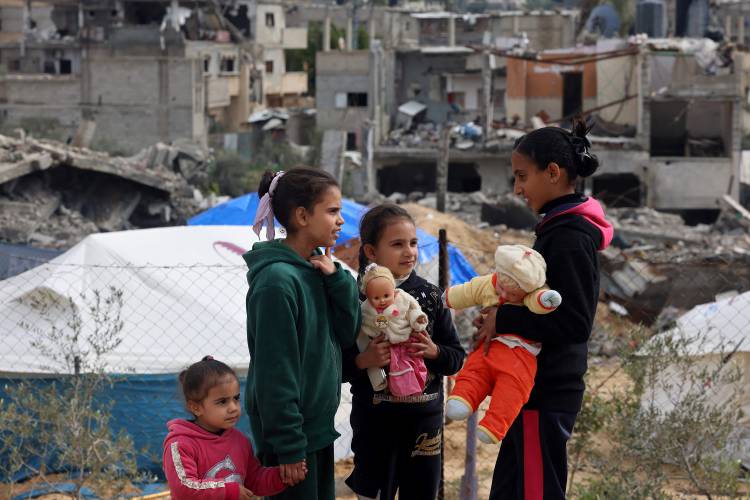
left=357, top=264, right=428, bottom=396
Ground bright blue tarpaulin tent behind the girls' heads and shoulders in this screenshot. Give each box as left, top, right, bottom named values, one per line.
left=188, top=193, right=477, bottom=285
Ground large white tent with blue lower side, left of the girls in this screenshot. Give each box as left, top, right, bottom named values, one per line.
left=0, top=226, right=353, bottom=480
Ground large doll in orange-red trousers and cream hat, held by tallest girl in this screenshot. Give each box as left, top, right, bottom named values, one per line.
left=443, top=245, right=562, bottom=443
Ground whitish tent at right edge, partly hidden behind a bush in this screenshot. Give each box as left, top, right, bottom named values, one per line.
left=645, top=292, right=750, bottom=464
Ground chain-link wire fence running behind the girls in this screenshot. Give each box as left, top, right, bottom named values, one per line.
left=0, top=240, right=750, bottom=498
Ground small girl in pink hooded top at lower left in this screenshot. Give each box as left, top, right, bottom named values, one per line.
left=163, top=356, right=296, bottom=500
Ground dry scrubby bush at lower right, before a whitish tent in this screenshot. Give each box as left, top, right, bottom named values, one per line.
left=569, top=327, right=741, bottom=499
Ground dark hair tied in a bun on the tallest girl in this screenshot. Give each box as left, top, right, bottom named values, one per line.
left=513, top=118, right=599, bottom=183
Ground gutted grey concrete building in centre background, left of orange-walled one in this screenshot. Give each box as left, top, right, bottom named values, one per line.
left=316, top=9, right=577, bottom=194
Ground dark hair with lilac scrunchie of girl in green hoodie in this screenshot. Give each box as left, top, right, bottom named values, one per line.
left=258, top=167, right=339, bottom=233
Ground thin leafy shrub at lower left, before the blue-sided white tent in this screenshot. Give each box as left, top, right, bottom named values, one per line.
left=0, top=288, right=137, bottom=498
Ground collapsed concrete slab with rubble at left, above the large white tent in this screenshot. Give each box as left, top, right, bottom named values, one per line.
left=0, top=134, right=210, bottom=249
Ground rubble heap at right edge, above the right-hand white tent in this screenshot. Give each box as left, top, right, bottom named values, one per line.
left=601, top=204, right=750, bottom=327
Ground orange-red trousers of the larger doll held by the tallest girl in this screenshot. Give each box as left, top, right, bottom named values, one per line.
left=450, top=340, right=536, bottom=441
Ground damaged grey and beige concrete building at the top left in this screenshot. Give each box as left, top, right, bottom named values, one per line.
left=0, top=0, right=307, bottom=154
